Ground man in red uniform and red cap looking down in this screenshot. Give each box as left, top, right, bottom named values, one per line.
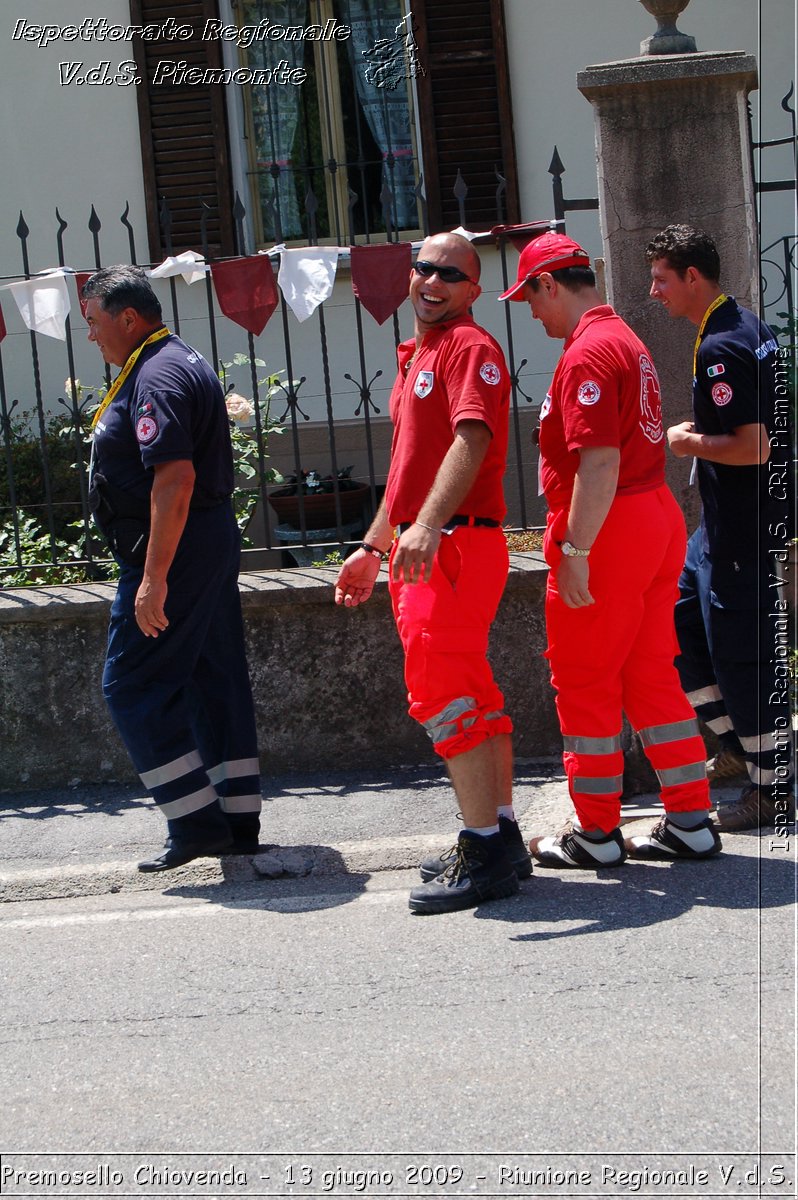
left=499, top=226, right=721, bottom=868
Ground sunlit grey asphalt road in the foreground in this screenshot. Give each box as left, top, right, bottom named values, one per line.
left=0, top=830, right=798, bottom=1196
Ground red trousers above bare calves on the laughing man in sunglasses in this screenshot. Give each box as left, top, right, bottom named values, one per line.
left=390, top=526, right=512, bottom=758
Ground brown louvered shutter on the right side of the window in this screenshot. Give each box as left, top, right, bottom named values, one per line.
left=412, top=0, right=521, bottom=233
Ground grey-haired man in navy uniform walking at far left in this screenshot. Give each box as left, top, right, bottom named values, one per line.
left=83, top=266, right=260, bottom=871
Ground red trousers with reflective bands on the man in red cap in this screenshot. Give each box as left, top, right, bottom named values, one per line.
left=544, top=486, right=710, bottom=833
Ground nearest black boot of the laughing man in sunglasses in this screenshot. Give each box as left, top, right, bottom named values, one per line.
left=409, top=829, right=518, bottom=914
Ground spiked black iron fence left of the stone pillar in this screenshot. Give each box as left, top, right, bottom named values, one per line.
left=0, top=174, right=547, bottom=587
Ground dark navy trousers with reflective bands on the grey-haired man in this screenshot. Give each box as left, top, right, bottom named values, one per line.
left=103, top=504, right=260, bottom=840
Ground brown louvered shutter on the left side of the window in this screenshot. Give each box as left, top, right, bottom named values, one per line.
left=131, top=0, right=235, bottom=262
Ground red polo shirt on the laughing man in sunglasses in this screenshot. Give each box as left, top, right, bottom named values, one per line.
left=385, top=317, right=510, bottom=526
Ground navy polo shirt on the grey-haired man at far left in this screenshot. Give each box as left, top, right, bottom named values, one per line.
left=94, top=334, right=233, bottom=508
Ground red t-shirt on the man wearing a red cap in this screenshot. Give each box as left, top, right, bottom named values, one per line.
left=540, top=305, right=665, bottom=509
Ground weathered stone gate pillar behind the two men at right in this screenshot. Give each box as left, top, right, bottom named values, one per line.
left=577, top=52, right=758, bottom=516
